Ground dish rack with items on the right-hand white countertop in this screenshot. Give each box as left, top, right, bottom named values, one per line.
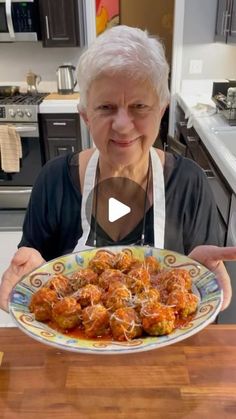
left=212, top=80, right=236, bottom=125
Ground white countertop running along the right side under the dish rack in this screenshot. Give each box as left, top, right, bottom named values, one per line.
left=176, top=92, right=236, bottom=193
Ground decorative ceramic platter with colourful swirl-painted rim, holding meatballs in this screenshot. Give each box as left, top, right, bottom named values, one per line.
left=9, top=246, right=223, bottom=354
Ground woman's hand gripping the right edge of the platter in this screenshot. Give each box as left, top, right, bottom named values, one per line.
left=189, top=246, right=236, bottom=310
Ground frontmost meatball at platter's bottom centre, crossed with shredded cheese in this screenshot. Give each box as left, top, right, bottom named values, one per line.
left=110, top=307, right=142, bottom=341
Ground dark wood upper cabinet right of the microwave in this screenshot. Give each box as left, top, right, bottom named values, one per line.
left=39, top=0, right=84, bottom=47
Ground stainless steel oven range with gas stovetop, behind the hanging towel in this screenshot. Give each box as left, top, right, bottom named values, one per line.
left=0, top=87, right=46, bottom=210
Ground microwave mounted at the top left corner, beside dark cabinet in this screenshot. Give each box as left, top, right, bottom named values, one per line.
left=0, top=0, right=41, bottom=42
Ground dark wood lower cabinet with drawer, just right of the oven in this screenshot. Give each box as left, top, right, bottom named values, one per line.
left=40, top=114, right=82, bottom=160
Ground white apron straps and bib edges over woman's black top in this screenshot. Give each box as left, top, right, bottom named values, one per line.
left=74, top=147, right=166, bottom=252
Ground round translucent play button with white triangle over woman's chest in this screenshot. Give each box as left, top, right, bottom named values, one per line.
left=85, top=177, right=150, bottom=246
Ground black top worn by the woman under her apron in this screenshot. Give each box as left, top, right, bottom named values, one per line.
left=19, top=153, right=222, bottom=260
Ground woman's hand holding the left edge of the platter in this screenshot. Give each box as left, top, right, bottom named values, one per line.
left=0, top=247, right=45, bottom=311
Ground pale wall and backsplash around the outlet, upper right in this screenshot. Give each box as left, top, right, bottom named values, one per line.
left=182, top=0, right=236, bottom=79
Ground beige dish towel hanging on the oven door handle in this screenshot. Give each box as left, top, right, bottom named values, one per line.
left=0, top=125, right=22, bottom=173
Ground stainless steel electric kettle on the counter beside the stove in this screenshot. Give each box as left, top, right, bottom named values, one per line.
left=57, top=64, right=77, bottom=95
